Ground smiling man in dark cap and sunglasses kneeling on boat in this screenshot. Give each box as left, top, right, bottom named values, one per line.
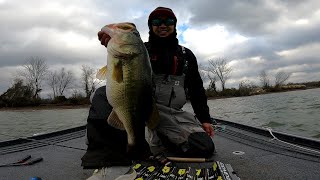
left=82, top=7, right=215, bottom=180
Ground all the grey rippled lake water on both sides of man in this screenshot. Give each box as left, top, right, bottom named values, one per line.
left=0, top=88, right=320, bottom=141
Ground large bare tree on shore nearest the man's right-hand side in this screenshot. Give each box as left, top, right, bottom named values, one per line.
left=208, top=58, right=232, bottom=90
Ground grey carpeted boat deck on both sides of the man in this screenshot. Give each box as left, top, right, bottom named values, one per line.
left=0, top=121, right=320, bottom=180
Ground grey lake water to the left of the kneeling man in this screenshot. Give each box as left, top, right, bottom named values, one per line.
left=0, top=108, right=89, bottom=141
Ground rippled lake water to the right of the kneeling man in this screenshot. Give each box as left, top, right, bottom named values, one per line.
left=184, top=88, right=320, bottom=139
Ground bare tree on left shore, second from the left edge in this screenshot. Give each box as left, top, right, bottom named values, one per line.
left=48, top=67, right=74, bottom=98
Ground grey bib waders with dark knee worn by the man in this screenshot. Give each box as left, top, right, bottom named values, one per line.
left=147, top=75, right=214, bottom=157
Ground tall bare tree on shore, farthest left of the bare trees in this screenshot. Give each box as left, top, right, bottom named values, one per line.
left=18, top=56, right=48, bottom=99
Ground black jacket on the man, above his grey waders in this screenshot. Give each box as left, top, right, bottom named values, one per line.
left=145, top=30, right=210, bottom=123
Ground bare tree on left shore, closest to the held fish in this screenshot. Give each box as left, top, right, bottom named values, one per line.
left=81, top=65, right=101, bottom=98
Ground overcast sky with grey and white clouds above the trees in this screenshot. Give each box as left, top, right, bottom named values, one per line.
left=0, top=0, right=320, bottom=97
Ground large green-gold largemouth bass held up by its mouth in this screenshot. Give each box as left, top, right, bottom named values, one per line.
left=97, top=23, right=159, bottom=159
